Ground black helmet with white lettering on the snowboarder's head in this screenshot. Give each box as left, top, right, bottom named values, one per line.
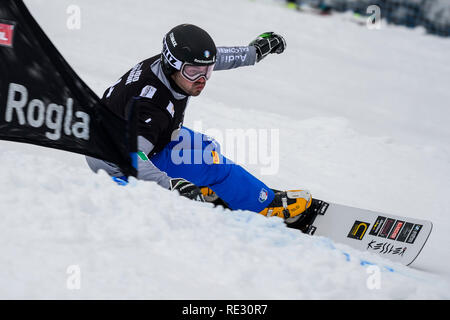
left=161, top=24, right=217, bottom=75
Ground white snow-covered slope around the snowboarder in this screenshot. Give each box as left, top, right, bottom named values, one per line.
left=0, top=0, right=450, bottom=299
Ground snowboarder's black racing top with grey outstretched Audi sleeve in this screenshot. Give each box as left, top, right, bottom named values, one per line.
left=101, top=46, right=256, bottom=156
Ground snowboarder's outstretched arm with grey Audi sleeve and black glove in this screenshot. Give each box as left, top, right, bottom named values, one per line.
left=214, top=32, right=286, bottom=71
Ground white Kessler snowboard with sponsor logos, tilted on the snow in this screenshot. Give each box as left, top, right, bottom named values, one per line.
left=285, top=199, right=433, bottom=265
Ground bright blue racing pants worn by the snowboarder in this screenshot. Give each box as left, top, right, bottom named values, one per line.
left=150, top=127, right=274, bottom=212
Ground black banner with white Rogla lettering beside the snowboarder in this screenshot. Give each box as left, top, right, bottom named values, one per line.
left=0, top=0, right=137, bottom=176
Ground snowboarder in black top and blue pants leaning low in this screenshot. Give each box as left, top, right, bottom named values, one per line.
left=86, top=24, right=312, bottom=219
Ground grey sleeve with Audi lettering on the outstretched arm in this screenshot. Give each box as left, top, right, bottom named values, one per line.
left=214, top=46, right=256, bottom=71
